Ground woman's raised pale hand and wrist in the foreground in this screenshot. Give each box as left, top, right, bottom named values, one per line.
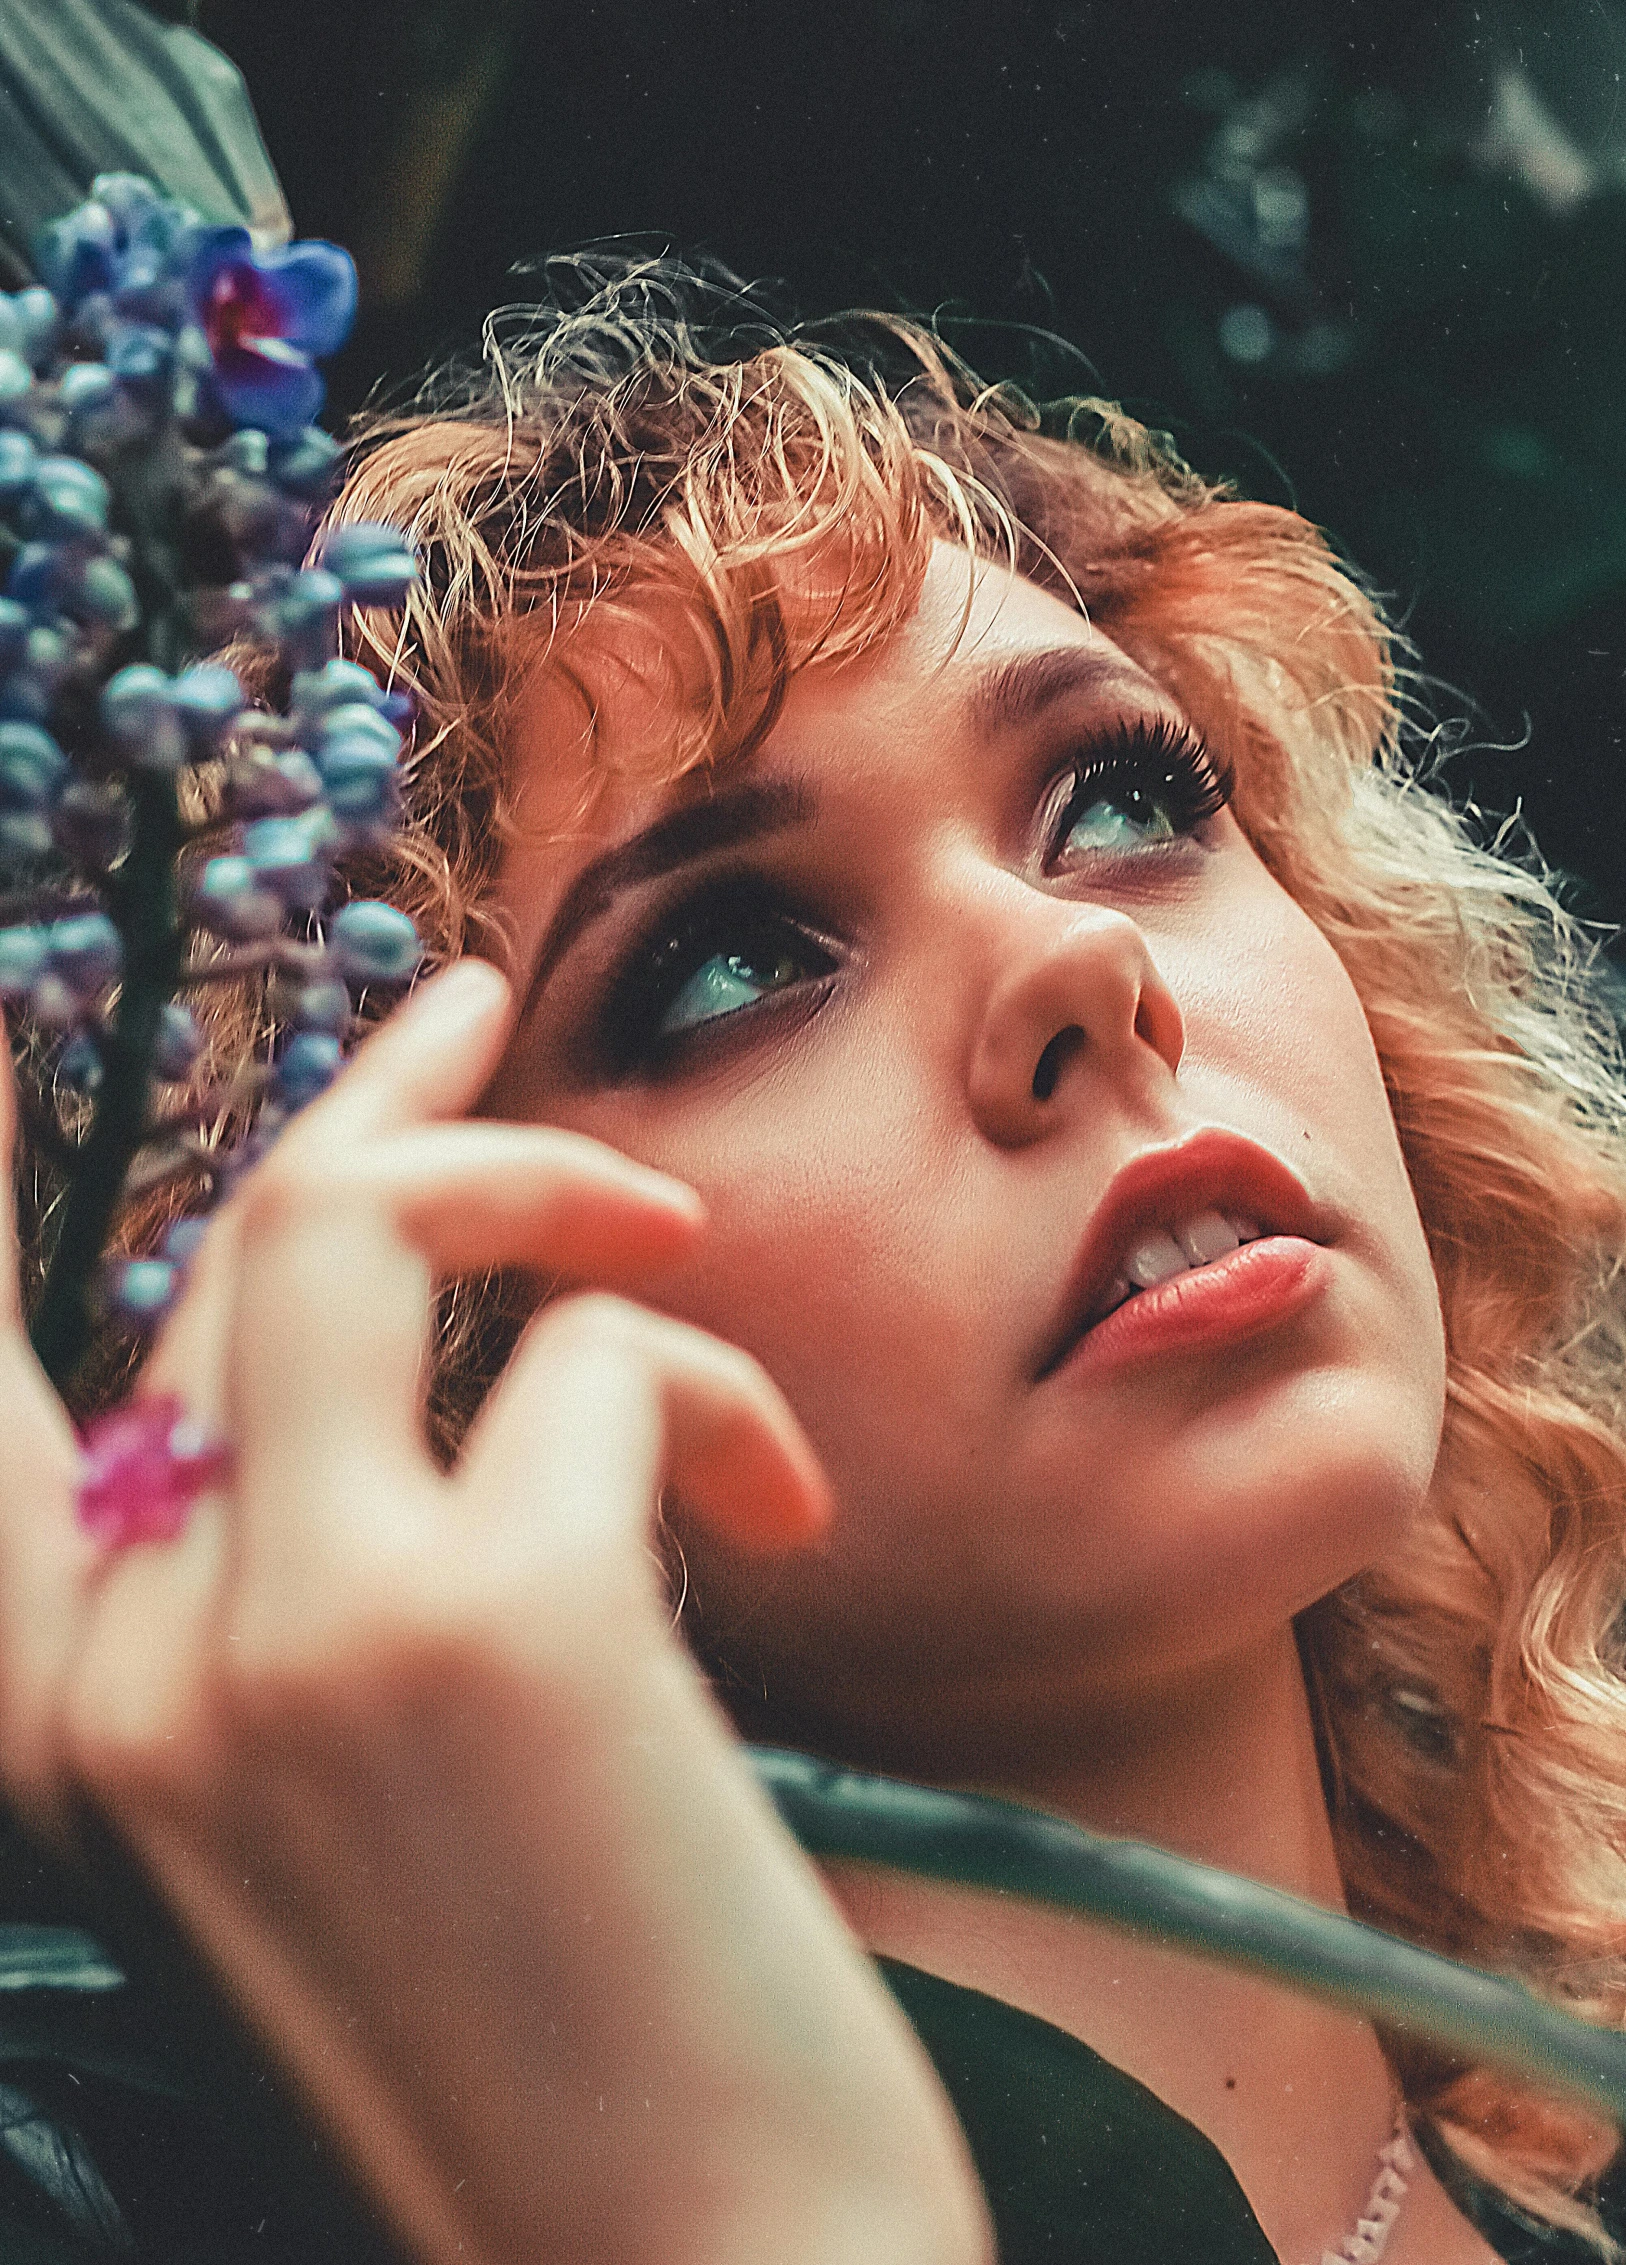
left=0, top=963, right=987, bottom=2265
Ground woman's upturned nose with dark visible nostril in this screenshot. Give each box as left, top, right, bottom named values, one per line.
left=969, top=899, right=1184, bottom=1148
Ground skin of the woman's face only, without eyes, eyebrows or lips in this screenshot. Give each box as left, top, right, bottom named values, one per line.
left=489, top=548, right=1443, bottom=1739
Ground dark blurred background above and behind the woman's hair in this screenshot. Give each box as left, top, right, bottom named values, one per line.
left=191, top=0, right=1626, bottom=920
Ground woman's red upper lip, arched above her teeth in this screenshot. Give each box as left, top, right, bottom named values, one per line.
left=1037, top=1126, right=1327, bottom=1377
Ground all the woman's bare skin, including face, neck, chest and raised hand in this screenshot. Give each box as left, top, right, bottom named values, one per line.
left=0, top=550, right=1488, bottom=2265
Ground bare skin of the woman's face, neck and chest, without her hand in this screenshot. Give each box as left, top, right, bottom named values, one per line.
left=487, top=546, right=1490, bottom=2265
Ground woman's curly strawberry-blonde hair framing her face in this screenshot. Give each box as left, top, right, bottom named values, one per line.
left=267, top=260, right=1626, bottom=2249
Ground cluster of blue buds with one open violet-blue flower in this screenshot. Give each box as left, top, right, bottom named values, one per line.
left=0, top=174, right=430, bottom=1323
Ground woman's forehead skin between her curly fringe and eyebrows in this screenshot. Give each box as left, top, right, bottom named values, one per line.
left=498, top=541, right=1166, bottom=933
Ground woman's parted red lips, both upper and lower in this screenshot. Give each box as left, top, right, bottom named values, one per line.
left=1037, top=1128, right=1327, bottom=1382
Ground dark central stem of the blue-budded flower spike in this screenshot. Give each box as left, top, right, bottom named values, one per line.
left=34, top=772, right=183, bottom=1391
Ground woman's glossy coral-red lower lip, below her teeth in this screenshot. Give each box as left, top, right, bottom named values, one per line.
left=1062, top=1234, right=1329, bottom=1370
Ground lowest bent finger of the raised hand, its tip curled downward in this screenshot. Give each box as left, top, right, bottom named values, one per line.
left=455, top=1296, right=831, bottom=1552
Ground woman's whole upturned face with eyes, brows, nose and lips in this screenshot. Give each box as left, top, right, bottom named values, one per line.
left=491, top=546, right=1443, bottom=1755
